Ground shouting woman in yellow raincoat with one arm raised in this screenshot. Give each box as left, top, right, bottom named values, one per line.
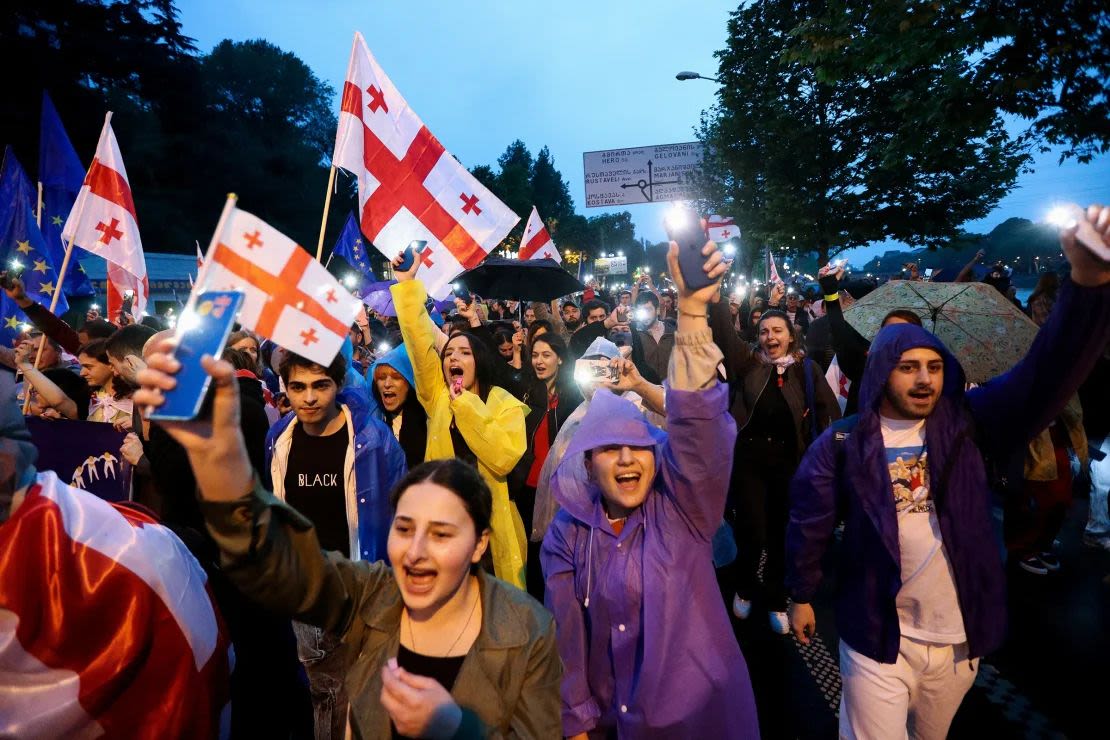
left=390, top=259, right=527, bottom=589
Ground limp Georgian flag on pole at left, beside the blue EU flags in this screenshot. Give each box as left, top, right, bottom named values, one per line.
left=62, top=112, right=150, bottom=317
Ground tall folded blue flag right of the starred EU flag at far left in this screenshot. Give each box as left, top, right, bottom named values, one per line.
left=39, top=90, right=94, bottom=296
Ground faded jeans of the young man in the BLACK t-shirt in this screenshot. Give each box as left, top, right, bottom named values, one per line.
left=293, top=621, right=347, bottom=740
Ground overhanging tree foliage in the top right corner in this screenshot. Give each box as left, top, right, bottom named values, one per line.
left=796, top=0, right=1110, bottom=162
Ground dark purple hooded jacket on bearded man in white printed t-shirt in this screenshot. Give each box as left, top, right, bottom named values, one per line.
left=786, top=280, right=1110, bottom=663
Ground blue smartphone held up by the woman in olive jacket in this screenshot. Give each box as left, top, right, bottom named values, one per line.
left=150, top=291, right=243, bottom=422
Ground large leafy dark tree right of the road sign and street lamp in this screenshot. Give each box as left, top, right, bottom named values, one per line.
left=700, top=0, right=1027, bottom=266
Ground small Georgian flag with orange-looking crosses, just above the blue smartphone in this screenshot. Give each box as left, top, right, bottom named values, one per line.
left=193, top=199, right=362, bottom=367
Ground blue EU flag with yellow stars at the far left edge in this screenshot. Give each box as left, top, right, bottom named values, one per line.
left=0, top=146, right=69, bottom=346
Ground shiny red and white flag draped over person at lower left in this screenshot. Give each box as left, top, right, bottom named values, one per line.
left=0, top=472, right=234, bottom=738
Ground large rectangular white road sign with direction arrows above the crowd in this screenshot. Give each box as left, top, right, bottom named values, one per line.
left=582, top=141, right=702, bottom=209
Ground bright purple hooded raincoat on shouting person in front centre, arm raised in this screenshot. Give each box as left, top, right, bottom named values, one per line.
left=541, top=372, right=759, bottom=739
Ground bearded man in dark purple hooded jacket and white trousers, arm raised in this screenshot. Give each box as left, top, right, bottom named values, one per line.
left=787, top=206, right=1110, bottom=739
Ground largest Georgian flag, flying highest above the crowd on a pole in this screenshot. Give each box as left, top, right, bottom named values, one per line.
left=332, top=32, right=519, bottom=300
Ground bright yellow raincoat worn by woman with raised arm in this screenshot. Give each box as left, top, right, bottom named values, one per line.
left=390, top=280, right=527, bottom=589
